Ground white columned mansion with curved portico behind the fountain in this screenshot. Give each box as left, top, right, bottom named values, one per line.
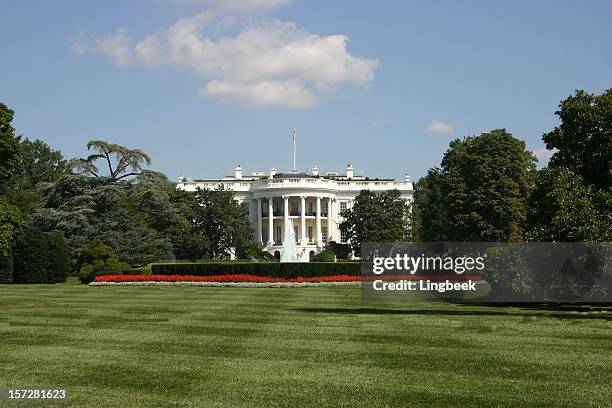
left=177, top=164, right=413, bottom=262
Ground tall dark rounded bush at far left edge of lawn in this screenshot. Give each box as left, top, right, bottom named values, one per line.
left=13, top=227, right=70, bottom=283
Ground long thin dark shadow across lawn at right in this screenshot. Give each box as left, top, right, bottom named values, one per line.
left=295, top=303, right=612, bottom=320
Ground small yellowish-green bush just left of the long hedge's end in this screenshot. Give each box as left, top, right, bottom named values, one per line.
left=79, top=241, right=130, bottom=283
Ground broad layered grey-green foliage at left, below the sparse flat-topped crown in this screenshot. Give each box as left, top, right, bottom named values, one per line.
left=34, top=174, right=177, bottom=266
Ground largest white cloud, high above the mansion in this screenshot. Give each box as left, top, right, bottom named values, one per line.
left=80, top=12, right=378, bottom=107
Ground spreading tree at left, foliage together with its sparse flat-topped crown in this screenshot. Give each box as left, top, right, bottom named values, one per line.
left=33, top=141, right=179, bottom=266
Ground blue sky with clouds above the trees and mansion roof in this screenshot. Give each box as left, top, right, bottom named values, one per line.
left=0, top=0, right=612, bottom=179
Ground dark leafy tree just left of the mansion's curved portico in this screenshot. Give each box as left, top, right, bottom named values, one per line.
left=194, top=186, right=253, bottom=259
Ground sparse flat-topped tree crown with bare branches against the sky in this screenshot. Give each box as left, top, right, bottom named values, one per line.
left=69, top=140, right=151, bottom=181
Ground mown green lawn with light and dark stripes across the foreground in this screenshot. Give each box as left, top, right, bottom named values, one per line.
left=0, top=282, right=612, bottom=407
